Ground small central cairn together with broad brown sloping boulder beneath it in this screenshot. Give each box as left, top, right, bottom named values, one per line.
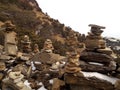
left=32, top=39, right=65, bottom=70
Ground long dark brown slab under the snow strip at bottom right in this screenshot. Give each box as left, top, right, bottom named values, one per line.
left=64, top=74, right=114, bottom=90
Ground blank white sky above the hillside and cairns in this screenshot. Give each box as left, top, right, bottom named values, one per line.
left=37, top=0, right=120, bottom=38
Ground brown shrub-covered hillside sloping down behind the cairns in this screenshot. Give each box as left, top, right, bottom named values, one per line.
left=0, top=0, right=84, bottom=54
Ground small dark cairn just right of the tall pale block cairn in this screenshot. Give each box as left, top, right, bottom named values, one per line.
left=21, top=35, right=32, bottom=53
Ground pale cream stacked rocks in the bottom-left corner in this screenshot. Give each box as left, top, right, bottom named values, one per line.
left=2, top=71, right=31, bottom=90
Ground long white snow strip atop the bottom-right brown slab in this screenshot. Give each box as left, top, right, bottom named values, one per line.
left=82, top=71, right=119, bottom=84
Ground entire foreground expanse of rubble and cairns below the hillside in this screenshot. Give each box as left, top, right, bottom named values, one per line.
left=0, top=23, right=120, bottom=90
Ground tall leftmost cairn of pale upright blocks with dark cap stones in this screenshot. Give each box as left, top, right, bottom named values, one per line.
left=2, top=21, right=18, bottom=56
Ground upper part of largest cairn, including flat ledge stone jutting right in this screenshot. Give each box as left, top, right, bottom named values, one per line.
left=85, top=24, right=113, bottom=55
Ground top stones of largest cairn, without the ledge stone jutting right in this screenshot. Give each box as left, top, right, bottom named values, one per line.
left=85, top=24, right=106, bottom=50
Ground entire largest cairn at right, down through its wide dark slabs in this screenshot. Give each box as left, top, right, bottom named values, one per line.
left=80, top=24, right=116, bottom=73
